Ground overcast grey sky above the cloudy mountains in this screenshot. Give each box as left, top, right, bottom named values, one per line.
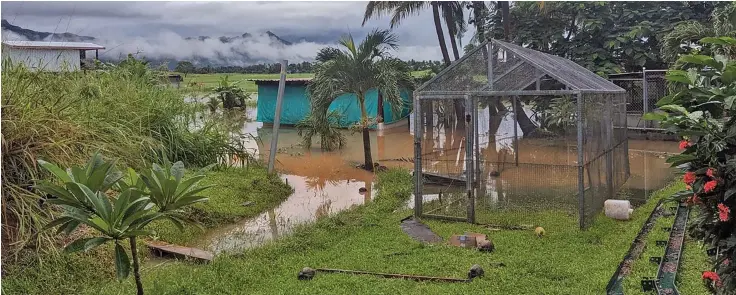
left=1, top=2, right=472, bottom=62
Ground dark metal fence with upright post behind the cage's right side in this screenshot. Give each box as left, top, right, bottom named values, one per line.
left=608, top=69, right=669, bottom=131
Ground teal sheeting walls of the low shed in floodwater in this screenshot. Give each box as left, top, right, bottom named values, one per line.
left=251, top=78, right=412, bottom=128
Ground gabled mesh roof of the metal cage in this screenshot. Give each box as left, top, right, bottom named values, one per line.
left=414, top=39, right=626, bottom=100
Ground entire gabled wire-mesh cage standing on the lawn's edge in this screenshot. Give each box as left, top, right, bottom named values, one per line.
left=413, top=40, right=629, bottom=228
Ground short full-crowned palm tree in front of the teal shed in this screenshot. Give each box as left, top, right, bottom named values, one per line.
left=308, top=30, right=414, bottom=171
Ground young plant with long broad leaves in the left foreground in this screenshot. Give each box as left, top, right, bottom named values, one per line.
left=37, top=154, right=161, bottom=279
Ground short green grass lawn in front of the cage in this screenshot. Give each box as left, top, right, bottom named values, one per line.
left=4, top=170, right=704, bottom=294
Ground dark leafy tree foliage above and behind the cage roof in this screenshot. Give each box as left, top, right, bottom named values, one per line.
left=482, top=1, right=727, bottom=73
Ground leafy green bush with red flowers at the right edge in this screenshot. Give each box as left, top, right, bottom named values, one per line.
left=648, top=37, right=736, bottom=294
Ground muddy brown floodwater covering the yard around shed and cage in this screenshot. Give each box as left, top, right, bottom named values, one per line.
left=190, top=108, right=678, bottom=254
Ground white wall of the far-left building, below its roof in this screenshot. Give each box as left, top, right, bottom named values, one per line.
left=2, top=46, right=80, bottom=72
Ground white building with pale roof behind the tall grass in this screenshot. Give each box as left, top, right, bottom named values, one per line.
left=2, top=41, right=105, bottom=72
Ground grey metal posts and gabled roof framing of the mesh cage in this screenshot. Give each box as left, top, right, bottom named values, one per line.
left=413, top=40, right=629, bottom=228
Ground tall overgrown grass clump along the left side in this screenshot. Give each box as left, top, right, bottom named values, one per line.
left=2, top=57, right=244, bottom=260
